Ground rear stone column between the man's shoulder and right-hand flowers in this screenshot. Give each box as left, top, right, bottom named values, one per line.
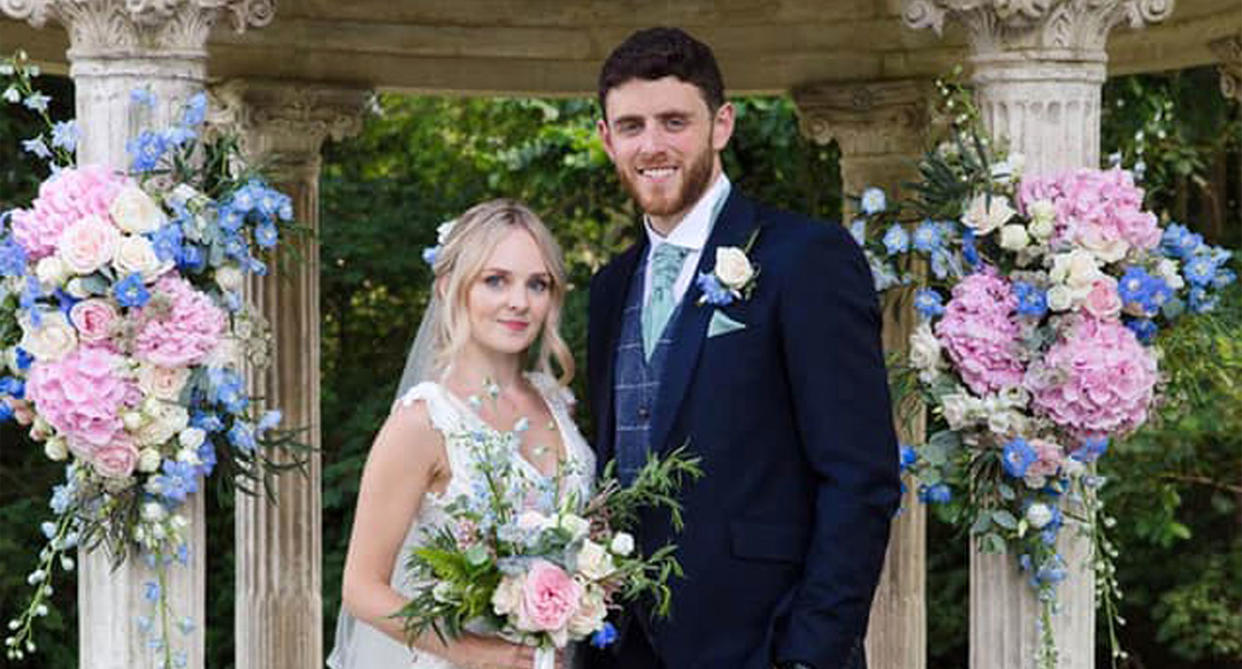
left=794, top=81, right=932, bottom=669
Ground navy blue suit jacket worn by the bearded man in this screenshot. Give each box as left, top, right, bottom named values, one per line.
left=587, top=190, right=900, bottom=669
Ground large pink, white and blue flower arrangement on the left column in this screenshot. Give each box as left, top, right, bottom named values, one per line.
left=0, top=56, right=303, bottom=667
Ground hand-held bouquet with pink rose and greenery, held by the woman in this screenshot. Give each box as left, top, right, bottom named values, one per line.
left=396, top=419, right=702, bottom=667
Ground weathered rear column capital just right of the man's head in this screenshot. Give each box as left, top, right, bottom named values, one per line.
left=794, top=79, right=933, bottom=156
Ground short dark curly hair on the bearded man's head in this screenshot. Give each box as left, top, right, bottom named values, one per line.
left=600, top=27, right=724, bottom=117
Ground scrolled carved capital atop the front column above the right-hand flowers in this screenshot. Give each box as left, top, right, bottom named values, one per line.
left=902, top=0, right=1175, bottom=61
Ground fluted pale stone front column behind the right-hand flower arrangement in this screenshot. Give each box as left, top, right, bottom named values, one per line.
left=904, top=0, right=1172, bottom=669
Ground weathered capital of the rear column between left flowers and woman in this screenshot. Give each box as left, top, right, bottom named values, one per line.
left=207, top=79, right=370, bottom=176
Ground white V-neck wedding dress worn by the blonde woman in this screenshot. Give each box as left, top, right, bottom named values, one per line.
left=328, top=372, right=595, bottom=669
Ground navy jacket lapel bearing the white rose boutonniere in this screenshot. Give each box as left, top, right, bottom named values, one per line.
left=651, top=187, right=758, bottom=452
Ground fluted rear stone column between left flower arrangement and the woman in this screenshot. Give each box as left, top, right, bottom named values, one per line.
left=212, top=81, right=366, bottom=669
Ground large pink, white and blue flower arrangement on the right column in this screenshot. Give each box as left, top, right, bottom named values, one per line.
left=854, top=81, right=1236, bottom=667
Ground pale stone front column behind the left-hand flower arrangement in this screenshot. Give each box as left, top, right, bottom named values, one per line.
left=0, top=0, right=273, bottom=669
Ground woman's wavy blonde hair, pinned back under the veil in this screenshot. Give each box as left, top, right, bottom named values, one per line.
left=432, top=199, right=574, bottom=386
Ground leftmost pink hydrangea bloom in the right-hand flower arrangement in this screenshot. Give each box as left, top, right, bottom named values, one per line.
left=935, top=272, right=1022, bottom=395
